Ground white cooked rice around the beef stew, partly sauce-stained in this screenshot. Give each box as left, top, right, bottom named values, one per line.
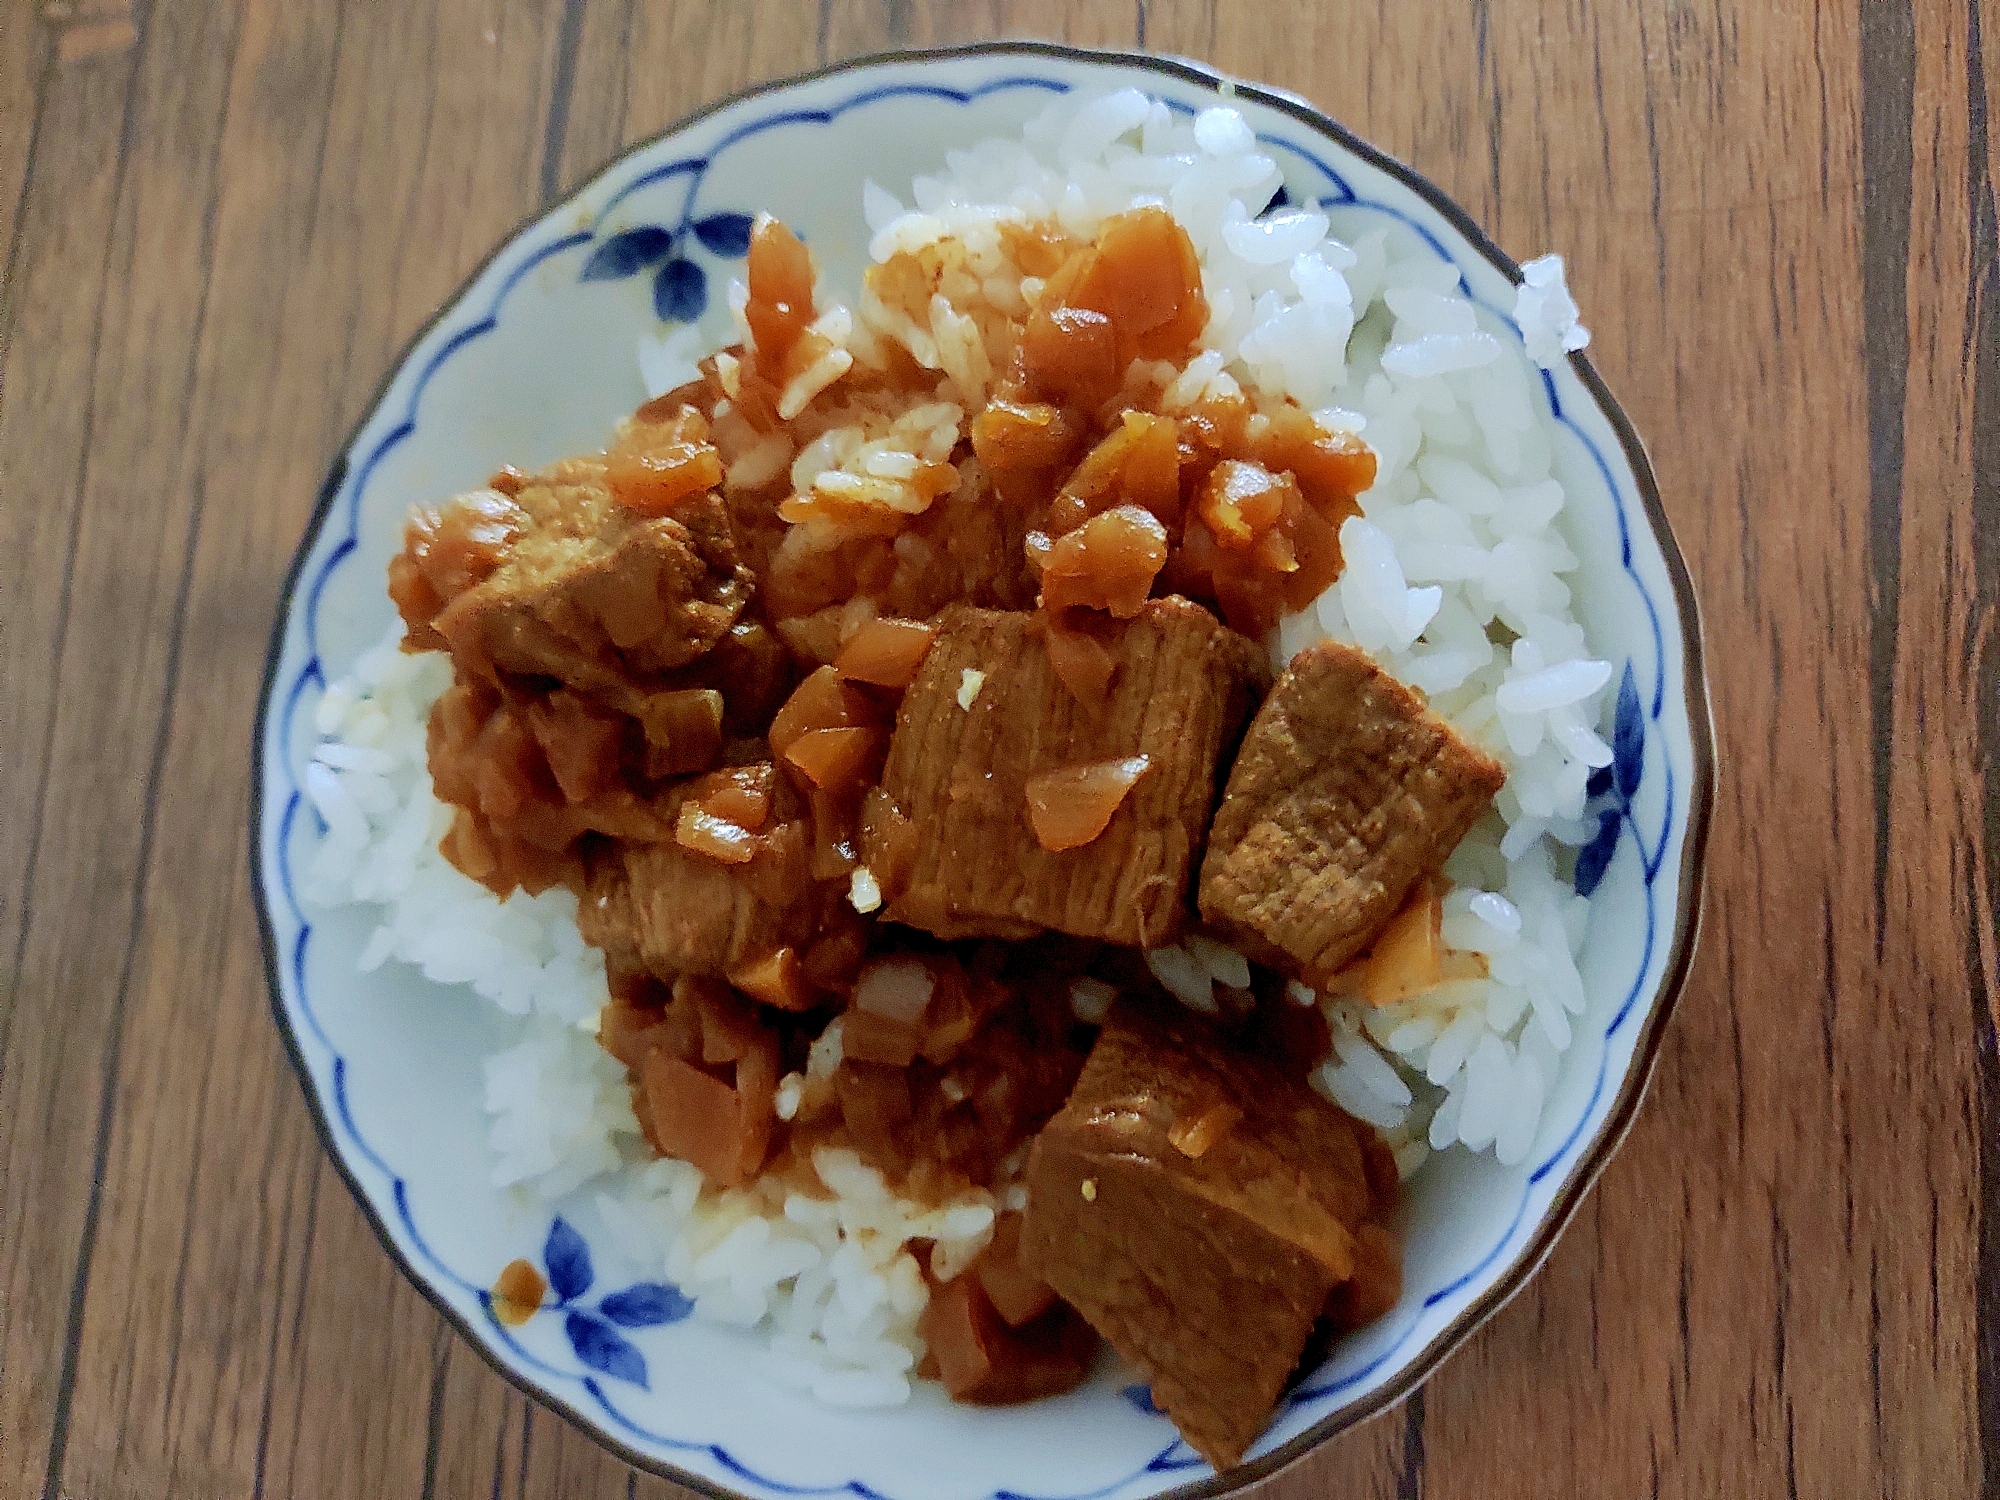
left=304, top=90, right=1612, bottom=1406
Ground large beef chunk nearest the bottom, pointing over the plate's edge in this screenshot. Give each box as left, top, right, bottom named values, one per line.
left=1020, top=1002, right=1394, bottom=1468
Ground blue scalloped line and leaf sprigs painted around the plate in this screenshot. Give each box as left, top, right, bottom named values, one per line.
left=242, top=48, right=1688, bottom=1500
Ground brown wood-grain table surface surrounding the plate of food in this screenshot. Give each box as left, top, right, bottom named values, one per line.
left=0, top=0, right=2000, bottom=1500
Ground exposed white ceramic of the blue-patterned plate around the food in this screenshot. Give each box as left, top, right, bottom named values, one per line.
left=254, top=46, right=1712, bottom=1500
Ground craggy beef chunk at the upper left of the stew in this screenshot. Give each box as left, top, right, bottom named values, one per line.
left=410, top=458, right=754, bottom=712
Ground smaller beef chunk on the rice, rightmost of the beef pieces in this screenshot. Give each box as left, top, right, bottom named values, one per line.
left=1200, top=642, right=1506, bottom=978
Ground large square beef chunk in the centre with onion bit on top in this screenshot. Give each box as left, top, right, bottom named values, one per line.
left=862, top=598, right=1264, bottom=946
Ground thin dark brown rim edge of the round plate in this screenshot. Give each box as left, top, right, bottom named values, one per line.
left=248, top=38, right=1716, bottom=1500
